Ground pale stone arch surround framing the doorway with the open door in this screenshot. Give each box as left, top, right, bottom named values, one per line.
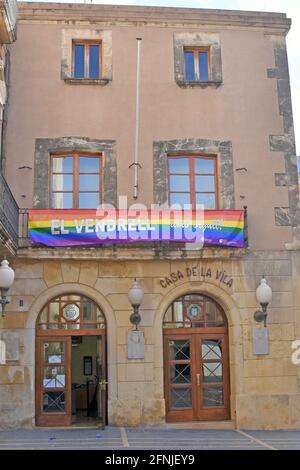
left=26, top=283, right=117, bottom=426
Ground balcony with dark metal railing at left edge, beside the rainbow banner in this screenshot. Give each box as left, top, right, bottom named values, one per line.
left=0, top=173, right=19, bottom=254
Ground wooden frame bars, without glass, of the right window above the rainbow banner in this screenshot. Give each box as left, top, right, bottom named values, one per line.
left=167, top=154, right=220, bottom=210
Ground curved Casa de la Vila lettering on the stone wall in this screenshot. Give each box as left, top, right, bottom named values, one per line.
left=160, top=266, right=233, bottom=289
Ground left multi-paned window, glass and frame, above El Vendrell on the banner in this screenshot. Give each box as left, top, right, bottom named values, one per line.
left=50, top=153, right=102, bottom=209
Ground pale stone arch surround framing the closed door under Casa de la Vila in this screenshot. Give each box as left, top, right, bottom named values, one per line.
left=153, top=282, right=244, bottom=422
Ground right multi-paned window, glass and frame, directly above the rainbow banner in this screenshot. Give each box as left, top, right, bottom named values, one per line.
left=168, top=155, right=218, bottom=209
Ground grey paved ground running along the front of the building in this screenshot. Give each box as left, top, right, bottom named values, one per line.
left=0, top=427, right=300, bottom=450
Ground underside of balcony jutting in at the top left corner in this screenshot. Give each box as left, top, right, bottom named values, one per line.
left=0, top=0, right=18, bottom=44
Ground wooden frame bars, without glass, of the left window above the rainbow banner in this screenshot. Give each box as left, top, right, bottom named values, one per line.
left=49, top=151, right=104, bottom=210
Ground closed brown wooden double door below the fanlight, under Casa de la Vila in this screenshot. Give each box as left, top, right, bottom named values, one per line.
left=164, top=328, right=230, bottom=422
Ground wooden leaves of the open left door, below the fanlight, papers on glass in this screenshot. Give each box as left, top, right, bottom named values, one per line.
left=36, top=331, right=107, bottom=426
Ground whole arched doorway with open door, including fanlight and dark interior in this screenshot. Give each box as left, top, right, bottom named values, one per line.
left=36, top=294, right=107, bottom=427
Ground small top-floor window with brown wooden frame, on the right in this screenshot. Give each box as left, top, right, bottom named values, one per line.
left=184, top=48, right=210, bottom=81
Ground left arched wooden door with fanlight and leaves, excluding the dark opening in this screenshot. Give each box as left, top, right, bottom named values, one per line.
left=36, top=294, right=106, bottom=426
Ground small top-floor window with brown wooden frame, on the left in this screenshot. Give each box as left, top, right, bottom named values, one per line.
left=73, top=41, right=101, bottom=80
